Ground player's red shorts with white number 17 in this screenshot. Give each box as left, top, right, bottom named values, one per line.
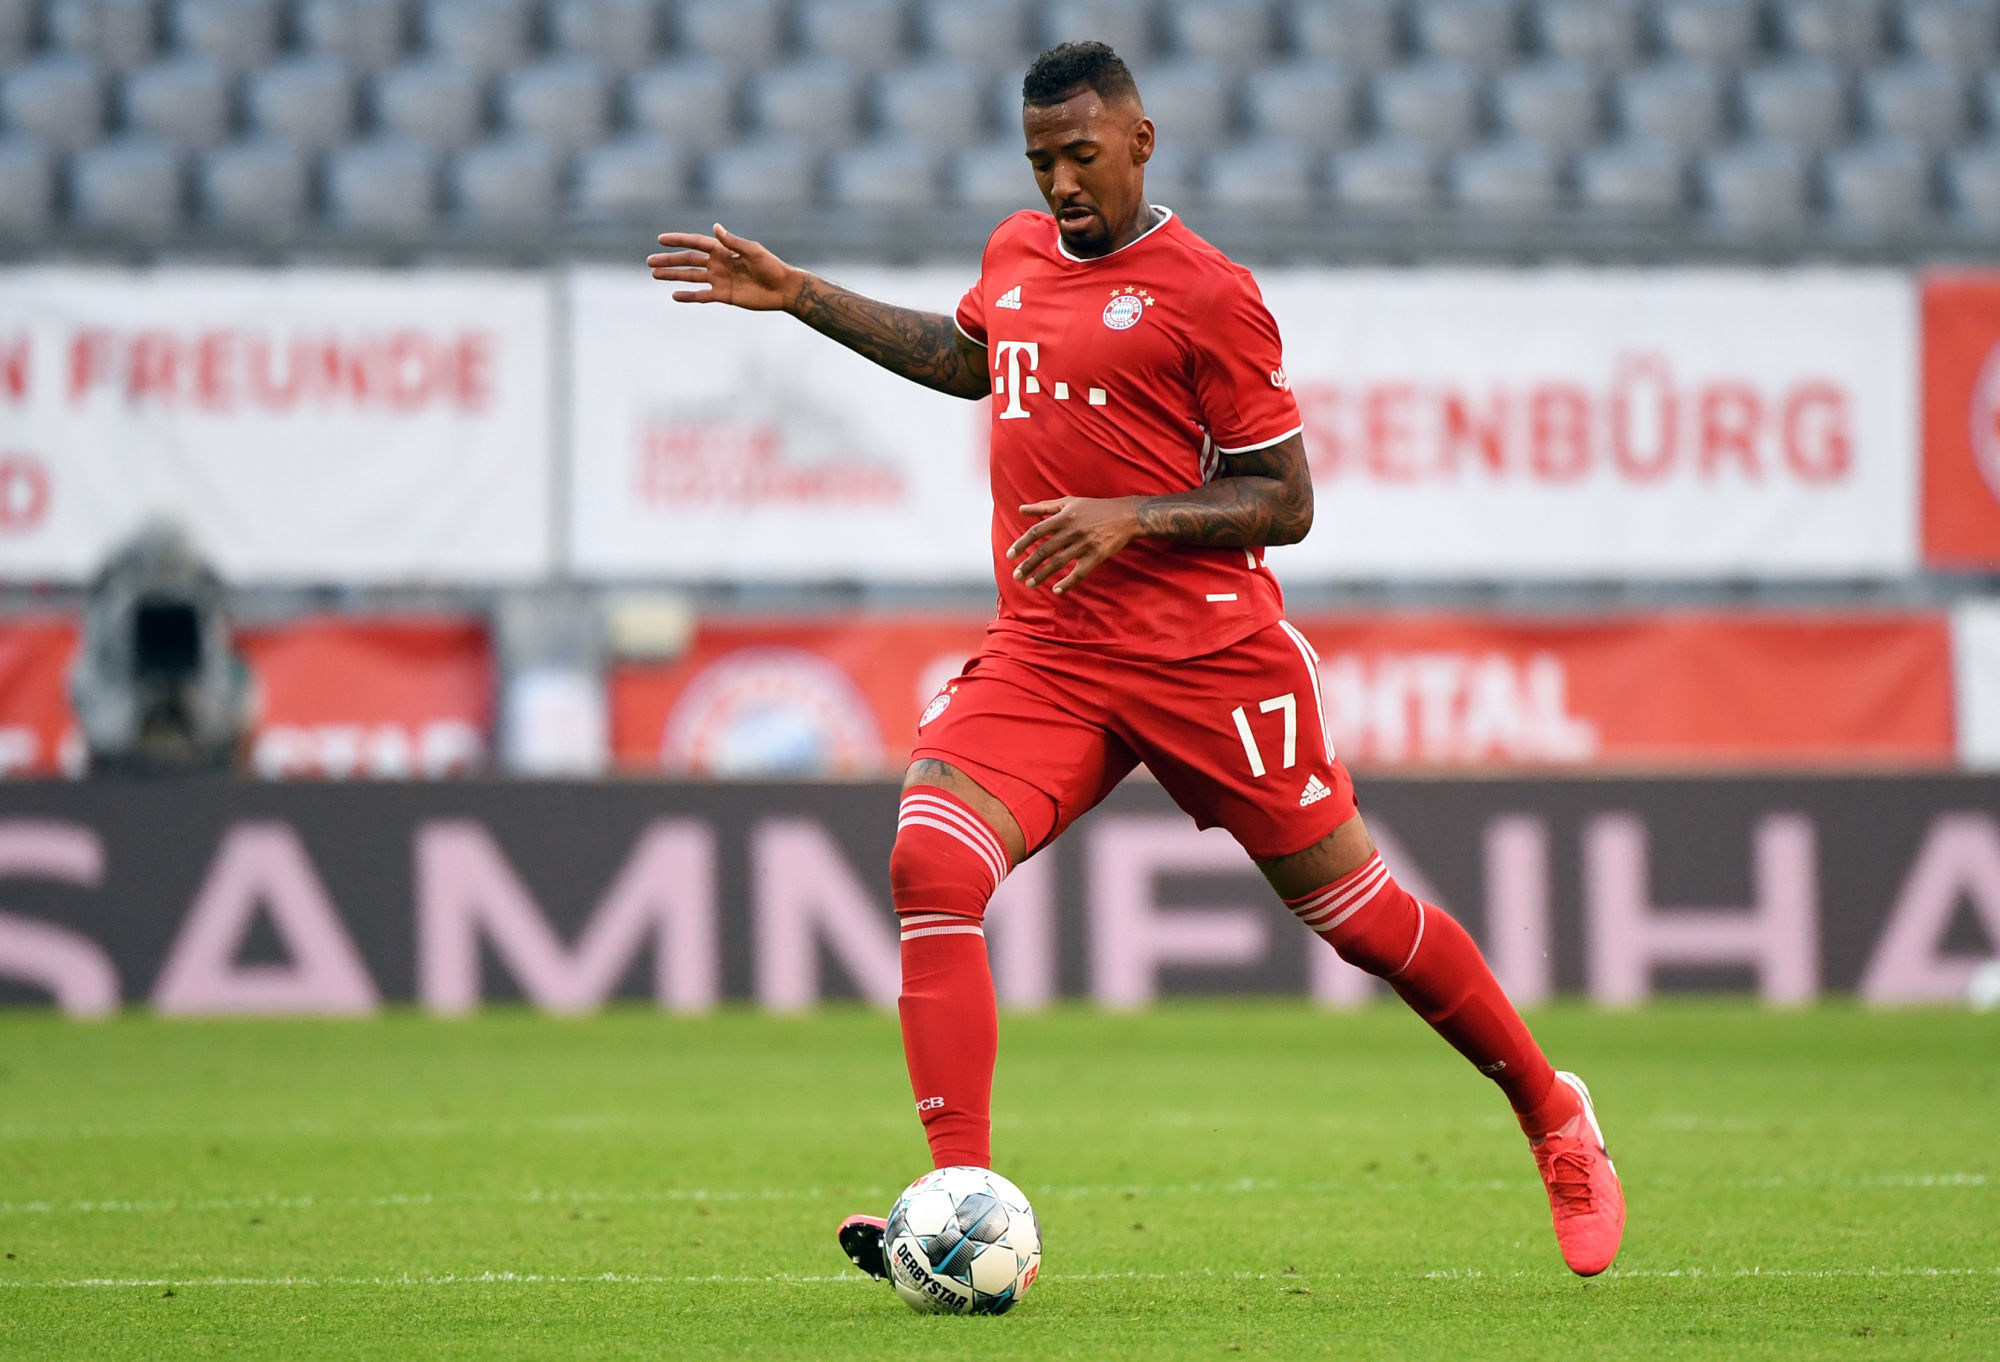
left=910, top=622, right=1356, bottom=860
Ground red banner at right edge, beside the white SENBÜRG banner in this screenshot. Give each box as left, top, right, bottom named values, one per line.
left=1924, top=274, right=2000, bottom=568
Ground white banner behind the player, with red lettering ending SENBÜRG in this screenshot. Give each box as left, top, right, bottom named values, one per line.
left=570, top=264, right=1918, bottom=580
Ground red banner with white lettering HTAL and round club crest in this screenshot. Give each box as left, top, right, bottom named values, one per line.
left=610, top=612, right=1954, bottom=776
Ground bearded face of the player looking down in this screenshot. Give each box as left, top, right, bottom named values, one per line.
left=1020, top=90, right=1152, bottom=256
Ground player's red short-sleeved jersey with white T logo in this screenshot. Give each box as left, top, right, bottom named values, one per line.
left=956, top=212, right=1300, bottom=660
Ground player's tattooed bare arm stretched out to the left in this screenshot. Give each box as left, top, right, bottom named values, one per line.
left=646, top=222, right=990, bottom=398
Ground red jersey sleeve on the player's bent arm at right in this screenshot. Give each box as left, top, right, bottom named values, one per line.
left=1194, top=274, right=1302, bottom=454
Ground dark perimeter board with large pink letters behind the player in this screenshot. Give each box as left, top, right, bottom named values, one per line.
left=0, top=776, right=2000, bottom=1016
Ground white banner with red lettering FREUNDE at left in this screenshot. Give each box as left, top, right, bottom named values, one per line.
left=0, top=268, right=554, bottom=582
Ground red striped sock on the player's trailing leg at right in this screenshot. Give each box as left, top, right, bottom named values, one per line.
left=1286, top=856, right=1574, bottom=1136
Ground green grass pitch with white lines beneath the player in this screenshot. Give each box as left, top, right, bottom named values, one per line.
left=0, top=1002, right=2000, bottom=1362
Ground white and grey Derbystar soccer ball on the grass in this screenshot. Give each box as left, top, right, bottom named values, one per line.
left=882, top=1168, right=1042, bottom=1314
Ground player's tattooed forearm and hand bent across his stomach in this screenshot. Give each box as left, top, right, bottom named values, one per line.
left=1006, top=436, right=1312, bottom=596
